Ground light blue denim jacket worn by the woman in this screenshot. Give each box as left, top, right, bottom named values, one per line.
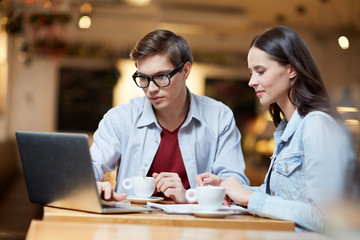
left=247, top=110, right=356, bottom=231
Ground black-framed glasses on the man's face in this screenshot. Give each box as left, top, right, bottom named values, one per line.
left=132, top=62, right=184, bottom=88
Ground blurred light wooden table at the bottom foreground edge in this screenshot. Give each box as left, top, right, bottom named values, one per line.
left=26, top=220, right=327, bottom=240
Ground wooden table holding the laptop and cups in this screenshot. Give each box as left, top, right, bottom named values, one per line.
left=43, top=207, right=295, bottom=231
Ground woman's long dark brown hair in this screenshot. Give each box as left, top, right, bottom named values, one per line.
left=250, top=26, right=340, bottom=126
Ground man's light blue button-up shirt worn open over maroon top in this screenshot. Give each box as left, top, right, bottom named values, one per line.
left=90, top=91, right=249, bottom=194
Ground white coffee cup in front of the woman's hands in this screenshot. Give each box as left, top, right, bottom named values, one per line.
left=185, top=186, right=225, bottom=211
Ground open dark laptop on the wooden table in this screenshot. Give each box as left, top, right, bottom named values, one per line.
left=16, top=132, right=151, bottom=213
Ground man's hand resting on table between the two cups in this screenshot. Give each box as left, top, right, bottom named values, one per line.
left=153, top=172, right=187, bottom=203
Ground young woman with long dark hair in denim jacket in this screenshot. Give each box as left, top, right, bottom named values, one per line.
left=197, top=26, right=356, bottom=231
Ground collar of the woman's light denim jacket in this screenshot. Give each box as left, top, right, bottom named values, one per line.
left=274, top=109, right=303, bottom=142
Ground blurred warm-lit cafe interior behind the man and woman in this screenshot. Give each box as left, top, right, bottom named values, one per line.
left=0, top=0, right=360, bottom=239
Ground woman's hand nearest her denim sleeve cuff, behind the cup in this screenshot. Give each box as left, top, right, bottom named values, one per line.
left=221, top=177, right=252, bottom=206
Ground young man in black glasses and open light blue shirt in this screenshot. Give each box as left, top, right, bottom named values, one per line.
left=90, top=30, right=248, bottom=203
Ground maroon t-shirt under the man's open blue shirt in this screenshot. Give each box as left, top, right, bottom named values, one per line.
left=147, top=125, right=190, bottom=199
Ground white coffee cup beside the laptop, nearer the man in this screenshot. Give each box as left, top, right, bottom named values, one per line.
left=122, top=177, right=155, bottom=198
